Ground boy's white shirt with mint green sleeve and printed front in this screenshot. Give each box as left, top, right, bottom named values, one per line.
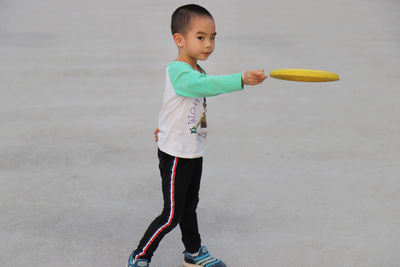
left=158, top=61, right=243, bottom=158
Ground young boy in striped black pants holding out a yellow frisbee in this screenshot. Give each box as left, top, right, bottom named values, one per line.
left=127, top=5, right=267, bottom=267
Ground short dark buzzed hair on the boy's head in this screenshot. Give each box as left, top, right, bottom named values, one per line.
left=171, top=4, right=214, bottom=35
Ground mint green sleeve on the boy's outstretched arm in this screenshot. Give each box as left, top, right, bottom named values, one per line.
left=168, top=61, right=243, bottom=97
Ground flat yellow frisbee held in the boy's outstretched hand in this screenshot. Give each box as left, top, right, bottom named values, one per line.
left=269, top=69, right=339, bottom=82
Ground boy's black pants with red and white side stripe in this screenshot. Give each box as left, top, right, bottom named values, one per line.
left=134, top=150, right=203, bottom=261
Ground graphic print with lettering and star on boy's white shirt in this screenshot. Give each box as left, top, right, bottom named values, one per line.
left=188, top=98, right=207, bottom=142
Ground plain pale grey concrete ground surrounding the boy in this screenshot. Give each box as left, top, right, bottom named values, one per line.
left=0, top=0, right=400, bottom=267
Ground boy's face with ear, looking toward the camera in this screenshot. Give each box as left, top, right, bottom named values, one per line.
left=174, top=16, right=217, bottom=61
